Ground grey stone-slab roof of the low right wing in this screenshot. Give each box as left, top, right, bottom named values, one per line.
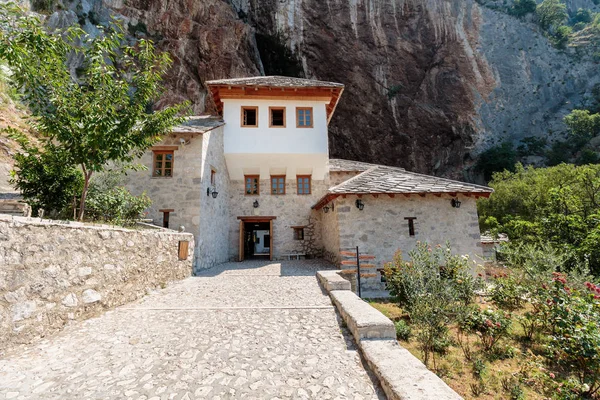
left=329, top=165, right=493, bottom=195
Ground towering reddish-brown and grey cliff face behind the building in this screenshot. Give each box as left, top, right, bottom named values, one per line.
left=42, top=0, right=600, bottom=178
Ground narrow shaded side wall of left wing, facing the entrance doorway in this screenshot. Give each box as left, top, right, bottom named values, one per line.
left=194, top=128, right=230, bottom=272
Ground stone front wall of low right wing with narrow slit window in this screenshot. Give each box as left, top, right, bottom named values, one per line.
left=335, top=195, right=482, bottom=265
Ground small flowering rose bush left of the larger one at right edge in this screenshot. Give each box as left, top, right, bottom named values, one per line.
left=461, top=309, right=511, bottom=352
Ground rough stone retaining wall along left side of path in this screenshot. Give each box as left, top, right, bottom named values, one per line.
left=0, top=215, right=194, bottom=353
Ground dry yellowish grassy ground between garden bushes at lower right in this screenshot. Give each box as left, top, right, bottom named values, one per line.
left=369, top=299, right=546, bottom=400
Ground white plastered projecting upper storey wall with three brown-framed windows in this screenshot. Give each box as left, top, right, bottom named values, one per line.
left=223, top=99, right=329, bottom=180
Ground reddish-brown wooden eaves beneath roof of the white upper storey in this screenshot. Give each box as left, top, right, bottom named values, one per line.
left=207, top=83, right=344, bottom=123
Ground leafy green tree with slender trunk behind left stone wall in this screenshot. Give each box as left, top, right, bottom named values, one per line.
left=0, top=6, right=185, bottom=220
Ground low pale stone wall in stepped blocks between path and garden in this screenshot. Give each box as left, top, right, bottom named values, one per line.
left=317, top=271, right=462, bottom=400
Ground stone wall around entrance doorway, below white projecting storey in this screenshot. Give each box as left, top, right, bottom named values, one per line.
left=229, top=177, right=327, bottom=260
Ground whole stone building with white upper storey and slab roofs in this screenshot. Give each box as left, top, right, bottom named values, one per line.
left=123, top=77, right=492, bottom=276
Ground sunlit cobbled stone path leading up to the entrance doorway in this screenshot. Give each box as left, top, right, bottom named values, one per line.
left=0, top=261, right=384, bottom=400
